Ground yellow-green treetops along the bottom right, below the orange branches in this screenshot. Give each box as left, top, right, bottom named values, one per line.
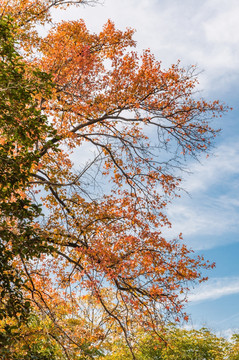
left=100, top=327, right=236, bottom=360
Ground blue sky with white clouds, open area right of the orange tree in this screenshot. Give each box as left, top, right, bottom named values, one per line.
left=51, top=0, right=239, bottom=335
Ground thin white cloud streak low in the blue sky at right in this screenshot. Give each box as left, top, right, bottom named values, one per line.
left=188, top=277, right=239, bottom=303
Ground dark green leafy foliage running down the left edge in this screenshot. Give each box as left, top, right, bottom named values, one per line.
left=0, top=16, right=53, bottom=324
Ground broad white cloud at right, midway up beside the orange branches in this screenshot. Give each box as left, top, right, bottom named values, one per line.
left=164, top=141, right=239, bottom=250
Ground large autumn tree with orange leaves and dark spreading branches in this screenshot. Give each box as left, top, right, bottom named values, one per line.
left=0, top=0, right=226, bottom=358
